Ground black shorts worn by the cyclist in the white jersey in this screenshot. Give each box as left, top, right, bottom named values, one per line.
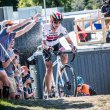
left=43, top=43, right=61, bottom=61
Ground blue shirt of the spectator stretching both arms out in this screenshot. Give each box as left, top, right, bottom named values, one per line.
left=0, top=28, right=16, bottom=62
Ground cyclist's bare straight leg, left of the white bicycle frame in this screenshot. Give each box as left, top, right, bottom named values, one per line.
left=45, top=61, right=53, bottom=93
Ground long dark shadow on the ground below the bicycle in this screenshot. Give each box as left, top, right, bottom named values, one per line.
left=0, top=99, right=93, bottom=110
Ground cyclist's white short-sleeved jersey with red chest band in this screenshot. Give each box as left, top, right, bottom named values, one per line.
left=43, top=24, right=68, bottom=46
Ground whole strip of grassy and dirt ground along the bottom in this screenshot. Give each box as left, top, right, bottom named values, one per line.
left=0, top=95, right=110, bottom=110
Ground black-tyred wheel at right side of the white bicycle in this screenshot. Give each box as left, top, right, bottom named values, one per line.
left=57, top=64, right=77, bottom=97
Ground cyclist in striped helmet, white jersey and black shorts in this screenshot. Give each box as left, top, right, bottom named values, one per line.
left=42, top=12, right=75, bottom=94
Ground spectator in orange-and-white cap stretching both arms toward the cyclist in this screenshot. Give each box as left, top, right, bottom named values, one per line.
left=0, top=15, right=38, bottom=98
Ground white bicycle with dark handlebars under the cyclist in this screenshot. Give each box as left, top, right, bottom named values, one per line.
left=43, top=51, right=77, bottom=99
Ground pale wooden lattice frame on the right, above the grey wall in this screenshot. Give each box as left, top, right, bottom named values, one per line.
left=75, top=12, right=110, bottom=45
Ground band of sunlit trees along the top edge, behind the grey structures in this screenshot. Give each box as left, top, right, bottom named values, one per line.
left=18, top=0, right=99, bottom=12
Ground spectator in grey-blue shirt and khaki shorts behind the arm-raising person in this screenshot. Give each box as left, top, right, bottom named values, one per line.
left=3, top=39, right=20, bottom=99
